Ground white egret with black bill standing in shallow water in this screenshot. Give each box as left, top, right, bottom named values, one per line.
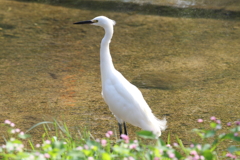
left=74, top=16, right=167, bottom=137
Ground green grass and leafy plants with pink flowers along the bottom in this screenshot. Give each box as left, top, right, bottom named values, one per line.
left=0, top=117, right=240, bottom=160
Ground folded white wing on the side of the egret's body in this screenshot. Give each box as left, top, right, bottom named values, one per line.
left=103, top=71, right=152, bottom=126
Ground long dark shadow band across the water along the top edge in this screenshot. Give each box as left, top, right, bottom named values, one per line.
left=14, top=0, right=240, bottom=20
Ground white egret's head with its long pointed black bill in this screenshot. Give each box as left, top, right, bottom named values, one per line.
left=74, top=16, right=116, bottom=28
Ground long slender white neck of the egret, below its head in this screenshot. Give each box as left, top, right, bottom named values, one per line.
left=100, top=26, right=114, bottom=81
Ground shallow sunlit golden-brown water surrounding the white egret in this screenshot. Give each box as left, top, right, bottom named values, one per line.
left=0, top=1, right=240, bottom=148
